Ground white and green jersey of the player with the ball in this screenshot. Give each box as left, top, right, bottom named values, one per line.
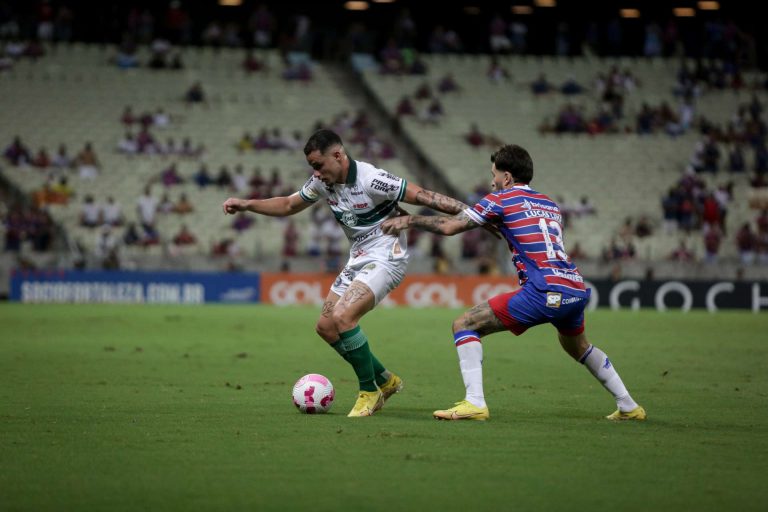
left=299, top=158, right=407, bottom=246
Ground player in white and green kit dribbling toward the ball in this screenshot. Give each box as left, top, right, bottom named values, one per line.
left=222, top=130, right=467, bottom=417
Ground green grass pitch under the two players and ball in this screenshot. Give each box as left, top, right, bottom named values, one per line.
left=0, top=304, right=768, bottom=512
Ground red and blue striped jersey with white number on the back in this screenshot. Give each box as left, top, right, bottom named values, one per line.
left=465, top=185, right=586, bottom=295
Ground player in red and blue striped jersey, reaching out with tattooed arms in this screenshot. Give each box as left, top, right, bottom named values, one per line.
left=382, top=145, right=646, bottom=420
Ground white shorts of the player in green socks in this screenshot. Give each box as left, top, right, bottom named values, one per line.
left=331, top=236, right=408, bottom=304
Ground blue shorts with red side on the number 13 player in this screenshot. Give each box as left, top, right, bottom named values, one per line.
left=488, top=286, right=590, bottom=336
